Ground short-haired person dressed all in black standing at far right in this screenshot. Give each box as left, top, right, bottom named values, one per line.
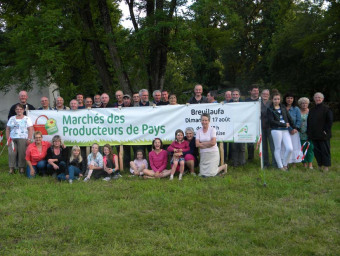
left=307, top=92, right=333, bottom=171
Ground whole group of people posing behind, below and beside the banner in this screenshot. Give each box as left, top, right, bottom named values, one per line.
left=6, top=85, right=333, bottom=183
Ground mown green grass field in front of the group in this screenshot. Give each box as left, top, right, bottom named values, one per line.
left=0, top=123, right=340, bottom=255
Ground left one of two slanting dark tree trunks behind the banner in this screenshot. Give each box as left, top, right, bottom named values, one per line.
left=79, top=0, right=113, bottom=93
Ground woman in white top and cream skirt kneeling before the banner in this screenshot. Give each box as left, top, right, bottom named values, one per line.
left=196, top=113, right=227, bottom=177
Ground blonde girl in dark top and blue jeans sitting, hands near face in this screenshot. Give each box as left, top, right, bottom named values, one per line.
left=58, top=146, right=86, bottom=184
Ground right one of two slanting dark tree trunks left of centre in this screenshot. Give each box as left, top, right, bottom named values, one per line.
left=98, top=0, right=132, bottom=94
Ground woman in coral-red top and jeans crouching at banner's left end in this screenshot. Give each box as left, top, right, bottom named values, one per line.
left=26, top=131, right=51, bottom=178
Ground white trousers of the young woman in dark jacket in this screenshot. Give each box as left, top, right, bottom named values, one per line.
left=272, top=130, right=293, bottom=168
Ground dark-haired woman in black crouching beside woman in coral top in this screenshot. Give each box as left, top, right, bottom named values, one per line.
left=46, top=135, right=67, bottom=177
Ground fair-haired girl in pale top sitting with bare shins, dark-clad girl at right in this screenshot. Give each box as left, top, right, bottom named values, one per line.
left=84, top=143, right=103, bottom=182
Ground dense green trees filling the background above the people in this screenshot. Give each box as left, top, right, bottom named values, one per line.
left=0, top=0, right=340, bottom=103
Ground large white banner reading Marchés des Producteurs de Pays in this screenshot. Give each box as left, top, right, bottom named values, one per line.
left=28, top=102, right=261, bottom=146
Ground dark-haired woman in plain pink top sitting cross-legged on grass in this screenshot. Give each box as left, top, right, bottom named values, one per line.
left=143, top=138, right=170, bottom=178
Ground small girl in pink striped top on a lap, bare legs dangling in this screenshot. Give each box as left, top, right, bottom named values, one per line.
left=168, top=129, right=190, bottom=180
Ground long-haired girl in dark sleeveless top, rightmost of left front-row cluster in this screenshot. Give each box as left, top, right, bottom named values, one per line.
left=103, top=144, right=121, bottom=181
